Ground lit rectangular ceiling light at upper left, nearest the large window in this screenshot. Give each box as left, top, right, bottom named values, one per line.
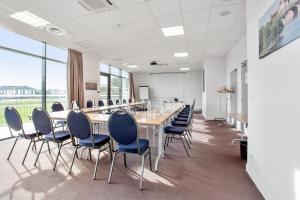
left=10, top=11, right=50, bottom=27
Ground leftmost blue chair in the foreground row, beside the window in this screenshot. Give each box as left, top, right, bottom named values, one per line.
left=4, top=107, right=40, bottom=164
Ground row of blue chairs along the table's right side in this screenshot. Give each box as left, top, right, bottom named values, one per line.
left=164, top=100, right=195, bottom=157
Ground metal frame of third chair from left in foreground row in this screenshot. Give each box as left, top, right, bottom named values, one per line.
left=67, top=110, right=112, bottom=180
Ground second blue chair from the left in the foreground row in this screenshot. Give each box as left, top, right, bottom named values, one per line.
left=32, top=108, right=70, bottom=170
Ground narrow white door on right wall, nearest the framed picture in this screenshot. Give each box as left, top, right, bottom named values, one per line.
left=241, top=61, right=248, bottom=115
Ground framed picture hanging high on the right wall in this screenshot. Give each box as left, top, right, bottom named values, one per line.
left=259, top=0, right=300, bottom=59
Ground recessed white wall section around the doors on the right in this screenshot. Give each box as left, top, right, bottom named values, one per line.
left=225, top=34, right=247, bottom=113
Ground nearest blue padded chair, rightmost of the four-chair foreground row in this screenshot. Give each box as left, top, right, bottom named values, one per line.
left=108, top=111, right=152, bottom=189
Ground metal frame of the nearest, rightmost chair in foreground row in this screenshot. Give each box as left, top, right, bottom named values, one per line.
left=108, top=110, right=152, bottom=190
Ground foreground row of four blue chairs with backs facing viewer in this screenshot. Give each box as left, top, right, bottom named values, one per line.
left=4, top=107, right=152, bottom=189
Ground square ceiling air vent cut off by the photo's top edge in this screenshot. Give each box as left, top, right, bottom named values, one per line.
left=78, top=0, right=113, bottom=11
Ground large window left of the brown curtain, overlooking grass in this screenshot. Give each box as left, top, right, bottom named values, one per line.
left=0, top=28, right=67, bottom=128
